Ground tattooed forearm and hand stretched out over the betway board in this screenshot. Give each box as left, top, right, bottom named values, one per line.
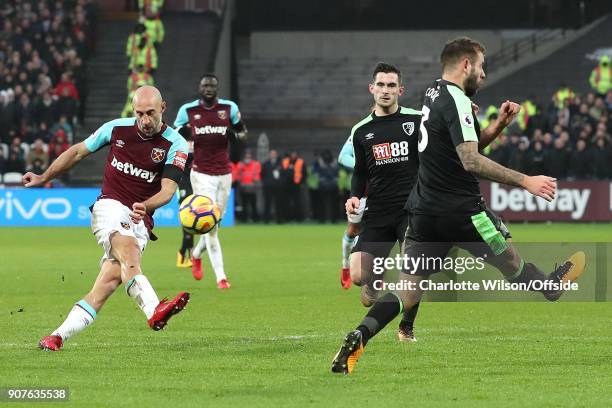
left=456, top=142, right=557, bottom=201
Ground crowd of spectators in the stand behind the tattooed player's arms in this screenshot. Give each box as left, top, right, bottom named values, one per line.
left=481, top=79, right=612, bottom=180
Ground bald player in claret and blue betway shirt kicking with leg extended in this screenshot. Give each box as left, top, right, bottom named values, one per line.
left=23, top=86, right=189, bottom=351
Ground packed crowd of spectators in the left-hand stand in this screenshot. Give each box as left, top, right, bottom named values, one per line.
left=0, top=0, right=96, bottom=180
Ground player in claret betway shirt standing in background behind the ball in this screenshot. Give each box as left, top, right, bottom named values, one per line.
left=174, top=74, right=247, bottom=289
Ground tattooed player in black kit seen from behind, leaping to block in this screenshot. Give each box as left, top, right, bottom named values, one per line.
left=332, top=37, right=585, bottom=374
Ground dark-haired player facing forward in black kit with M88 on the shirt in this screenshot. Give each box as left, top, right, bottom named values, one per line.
left=346, top=62, right=421, bottom=341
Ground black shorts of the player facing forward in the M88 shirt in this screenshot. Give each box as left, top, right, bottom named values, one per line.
left=351, top=210, right=408, bottom=258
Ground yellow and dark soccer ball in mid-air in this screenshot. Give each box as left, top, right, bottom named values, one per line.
left=179, top=194, right=221, bottom=234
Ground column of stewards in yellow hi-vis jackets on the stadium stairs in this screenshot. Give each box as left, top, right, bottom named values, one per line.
left=121, top=0, right=165, bottom=118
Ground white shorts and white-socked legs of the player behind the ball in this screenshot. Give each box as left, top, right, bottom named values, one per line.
left=191, top=170, right=232, bottom=289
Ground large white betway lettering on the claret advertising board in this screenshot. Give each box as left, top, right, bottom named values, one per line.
left=491, top=183, right=591, bottom=220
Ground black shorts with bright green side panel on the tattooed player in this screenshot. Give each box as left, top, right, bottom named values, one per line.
left=402, top=203, right=512, bottom=275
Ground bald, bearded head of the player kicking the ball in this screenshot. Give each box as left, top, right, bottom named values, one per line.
left=132, top=85, right=166, bottom=136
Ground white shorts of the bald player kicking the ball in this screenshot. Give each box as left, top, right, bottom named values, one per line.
left=91, top=198, right=149, bottom=265
